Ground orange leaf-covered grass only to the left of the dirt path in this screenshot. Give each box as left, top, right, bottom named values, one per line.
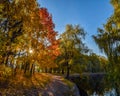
left=0, top=73, right=51, bottom=96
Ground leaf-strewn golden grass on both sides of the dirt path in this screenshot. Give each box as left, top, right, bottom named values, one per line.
left=0, top=66, right=74, bottom=96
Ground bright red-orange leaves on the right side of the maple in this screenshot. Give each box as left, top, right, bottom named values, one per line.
left=39, top=8, right=60, bottom=59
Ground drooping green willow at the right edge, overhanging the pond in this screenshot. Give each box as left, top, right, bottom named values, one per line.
left=93, top=0, right=120, bottom=96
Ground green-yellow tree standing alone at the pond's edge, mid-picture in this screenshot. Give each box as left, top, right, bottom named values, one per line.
left=60, top=25, right=87, bottom=78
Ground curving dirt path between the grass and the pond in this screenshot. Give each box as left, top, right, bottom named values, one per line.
left=43, top=75, right=80, bottom=96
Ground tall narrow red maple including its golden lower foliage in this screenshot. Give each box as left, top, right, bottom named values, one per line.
left=35, top=8, right=60, bottom=67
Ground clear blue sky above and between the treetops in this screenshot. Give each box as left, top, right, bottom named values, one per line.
left=38, top=0, right=113, bottom=55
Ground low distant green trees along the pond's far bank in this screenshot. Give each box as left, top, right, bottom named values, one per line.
left=72, top=53, right=108, bottom=73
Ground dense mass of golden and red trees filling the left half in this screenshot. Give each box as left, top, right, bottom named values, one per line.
left=0, top=0, right=59, bottom=76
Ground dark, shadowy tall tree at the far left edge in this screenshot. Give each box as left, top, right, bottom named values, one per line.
left=0, top=0, right=22, bottom=65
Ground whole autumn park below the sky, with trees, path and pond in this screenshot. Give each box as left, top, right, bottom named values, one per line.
left=0, top=0, right=120, bottom=96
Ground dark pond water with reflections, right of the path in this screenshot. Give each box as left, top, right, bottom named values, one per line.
left=70, top=73, right=116, bottom=96
